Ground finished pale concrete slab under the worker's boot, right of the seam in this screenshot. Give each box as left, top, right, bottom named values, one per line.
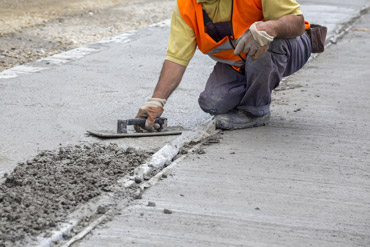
left=74, top=4, right=370, bottom=247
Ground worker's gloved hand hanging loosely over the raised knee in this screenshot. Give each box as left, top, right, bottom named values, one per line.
left=234, top=22, right=274, bottom=61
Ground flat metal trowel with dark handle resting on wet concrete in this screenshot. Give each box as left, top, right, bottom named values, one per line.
left=87, top=117, right=182, bottom=138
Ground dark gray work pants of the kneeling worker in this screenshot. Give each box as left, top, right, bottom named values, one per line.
left=198, top=34, right=311, bottom=116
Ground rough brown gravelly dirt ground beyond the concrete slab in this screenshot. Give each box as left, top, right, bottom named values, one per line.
left=0, top=0, right=175, bottom=71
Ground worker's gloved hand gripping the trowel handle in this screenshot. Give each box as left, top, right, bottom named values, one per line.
left=134, top=98, right=166, bottom=132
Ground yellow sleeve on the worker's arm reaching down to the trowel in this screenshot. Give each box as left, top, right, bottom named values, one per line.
left=166, top=3, right=197, bottom=66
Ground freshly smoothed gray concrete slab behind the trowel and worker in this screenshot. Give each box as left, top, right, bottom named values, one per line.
left=0, top=0, right=367, bottom=177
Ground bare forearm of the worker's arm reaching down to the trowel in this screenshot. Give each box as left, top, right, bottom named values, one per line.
left=153, top=60, right=186, bottom=99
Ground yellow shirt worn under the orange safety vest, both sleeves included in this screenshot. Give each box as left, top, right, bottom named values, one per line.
left=166, top=0, right=302, bottom=66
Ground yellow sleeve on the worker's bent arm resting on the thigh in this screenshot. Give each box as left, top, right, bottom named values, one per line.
left=262, top=0, right=302, bottom=21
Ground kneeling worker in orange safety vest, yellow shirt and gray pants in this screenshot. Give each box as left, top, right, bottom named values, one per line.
left=135, top=0, right=311, bottom=131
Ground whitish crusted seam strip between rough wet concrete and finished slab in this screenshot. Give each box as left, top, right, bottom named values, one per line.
left=35, top=119, right=217, bottom=247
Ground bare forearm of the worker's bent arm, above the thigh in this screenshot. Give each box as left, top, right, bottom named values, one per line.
left=257, top=15, right=305, bottom=39
